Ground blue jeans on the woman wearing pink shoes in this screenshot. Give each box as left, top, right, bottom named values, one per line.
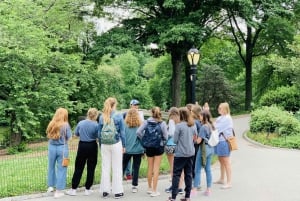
left=194, top=145, right=214, bottom=188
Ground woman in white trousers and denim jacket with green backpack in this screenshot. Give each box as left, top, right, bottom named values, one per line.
left=98, top=97, right=126, bottom=199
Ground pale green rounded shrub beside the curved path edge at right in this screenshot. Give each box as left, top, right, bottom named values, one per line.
left=250, top=106, right=300, bottom=135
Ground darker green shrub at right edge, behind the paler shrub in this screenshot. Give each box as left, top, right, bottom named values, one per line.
left=259, top=86, right=300, bottom=113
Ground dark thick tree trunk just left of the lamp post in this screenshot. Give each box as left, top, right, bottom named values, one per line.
left=171, top=50, right=182, bottom=107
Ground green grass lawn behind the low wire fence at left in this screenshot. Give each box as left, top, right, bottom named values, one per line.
left=0, top=139, right=169, bottom=198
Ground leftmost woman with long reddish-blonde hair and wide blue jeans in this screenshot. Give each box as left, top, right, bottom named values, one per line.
left=46, top=108, right=72, bottom=198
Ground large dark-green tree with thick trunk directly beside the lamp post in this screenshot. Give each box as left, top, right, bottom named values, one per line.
left=91, top=0, right=227, bottom=106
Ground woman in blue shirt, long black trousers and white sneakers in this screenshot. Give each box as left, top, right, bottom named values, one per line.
left=66, top=108, right=99, bottom=195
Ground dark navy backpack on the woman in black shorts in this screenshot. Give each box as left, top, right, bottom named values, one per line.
left=141, top=121, right=164, bottom=148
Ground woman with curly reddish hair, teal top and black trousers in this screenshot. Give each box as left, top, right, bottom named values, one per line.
left=123, top=108, right=144, bottom=193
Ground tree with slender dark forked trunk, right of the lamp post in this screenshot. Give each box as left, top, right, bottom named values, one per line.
left=226, top=0, right=298, bottom=110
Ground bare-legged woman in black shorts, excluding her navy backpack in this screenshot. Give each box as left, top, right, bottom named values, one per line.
left=137, top=107, right=168, bottom=197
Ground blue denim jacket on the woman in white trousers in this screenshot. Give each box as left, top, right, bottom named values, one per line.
left=98, top=111, right=126, bottom=147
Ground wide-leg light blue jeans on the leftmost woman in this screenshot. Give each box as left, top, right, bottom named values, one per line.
left=48, top=144, right=69, bottom=190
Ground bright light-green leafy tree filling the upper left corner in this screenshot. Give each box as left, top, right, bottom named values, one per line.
left=0, top=0, right=94, bottom=144
